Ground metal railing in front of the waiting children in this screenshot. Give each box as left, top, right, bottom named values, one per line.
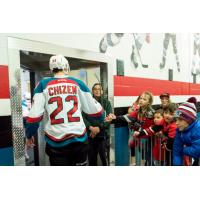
left=130, top=136, right=200, bottom=166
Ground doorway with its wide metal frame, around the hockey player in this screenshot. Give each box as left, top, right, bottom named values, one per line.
left=8, top=38, right=114, bottom=165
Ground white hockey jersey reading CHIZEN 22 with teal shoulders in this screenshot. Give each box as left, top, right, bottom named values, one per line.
left=26, top=76, right=105, bottom=146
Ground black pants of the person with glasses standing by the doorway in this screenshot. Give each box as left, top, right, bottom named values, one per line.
left=88, top=138, right=107, bottom=166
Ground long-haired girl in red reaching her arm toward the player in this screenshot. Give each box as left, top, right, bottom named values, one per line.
left=105, top=91, right=154, bottom=165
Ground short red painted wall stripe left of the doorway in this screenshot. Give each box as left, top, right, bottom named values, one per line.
left=0, top=65, right=10, bottom=99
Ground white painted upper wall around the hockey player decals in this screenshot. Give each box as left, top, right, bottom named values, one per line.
left=0, top=33, right=195, bottom=83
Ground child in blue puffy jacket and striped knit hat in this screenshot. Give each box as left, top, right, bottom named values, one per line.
left=173, top=102, right=200, bottom=165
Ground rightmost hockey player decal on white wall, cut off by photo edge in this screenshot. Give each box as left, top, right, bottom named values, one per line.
left=191, top=33, right=200, bottom=76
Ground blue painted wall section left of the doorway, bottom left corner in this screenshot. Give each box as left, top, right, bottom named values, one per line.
left=0, top=147, right=14, bottom=166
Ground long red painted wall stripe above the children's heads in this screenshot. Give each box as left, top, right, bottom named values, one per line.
left=114, top=76, right=200, bottom=96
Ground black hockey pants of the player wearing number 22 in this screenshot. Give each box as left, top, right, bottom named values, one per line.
left=45, top=142, right=88, bottom=166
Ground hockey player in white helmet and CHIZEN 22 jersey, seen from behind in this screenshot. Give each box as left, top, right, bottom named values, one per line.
left=26, top=55, right=104, bottom=166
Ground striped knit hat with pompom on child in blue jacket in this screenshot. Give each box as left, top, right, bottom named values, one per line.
left=174, top=102, right=197, bottom=124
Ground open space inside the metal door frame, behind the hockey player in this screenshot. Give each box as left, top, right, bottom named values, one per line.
left=20, top=51, right=104, bottom=166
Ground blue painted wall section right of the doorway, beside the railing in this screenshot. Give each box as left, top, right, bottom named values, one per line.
left=115, top=126, right=129, bottom=166
